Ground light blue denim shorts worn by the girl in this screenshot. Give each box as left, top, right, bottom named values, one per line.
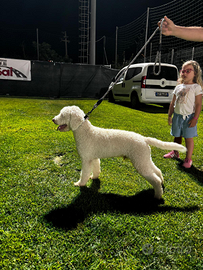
left=171, top=113, right=198, bottom=139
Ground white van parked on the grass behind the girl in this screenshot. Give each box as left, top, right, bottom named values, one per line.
left=109, top=63, right=178, bottom=108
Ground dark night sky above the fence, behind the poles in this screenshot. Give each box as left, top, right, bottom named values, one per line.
left=0, top=0, right=171, bottom=62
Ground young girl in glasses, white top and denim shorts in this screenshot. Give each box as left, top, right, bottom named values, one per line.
left=164, top=60, right=203, bottom=168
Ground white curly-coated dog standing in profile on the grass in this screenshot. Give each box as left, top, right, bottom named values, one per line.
left=53, top=106, right=186, bottom=199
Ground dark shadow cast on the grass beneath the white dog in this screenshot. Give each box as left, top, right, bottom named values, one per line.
left=44, top=179, right=199, bottom=230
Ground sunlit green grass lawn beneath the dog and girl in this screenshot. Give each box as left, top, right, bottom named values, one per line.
left=0, top=98, right=203, bottom=270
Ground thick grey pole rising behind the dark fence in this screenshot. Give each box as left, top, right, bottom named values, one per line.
left=90, top=0, right=96, bottom=65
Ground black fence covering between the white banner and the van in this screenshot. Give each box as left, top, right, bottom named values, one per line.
left=0, top=61, right=118, bottom=98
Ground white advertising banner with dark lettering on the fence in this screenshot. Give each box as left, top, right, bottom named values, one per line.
left=0, top=58, right=31, bottom=81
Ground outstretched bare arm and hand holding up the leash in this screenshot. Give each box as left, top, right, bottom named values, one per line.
left=158, top=16, right=203, bottom=42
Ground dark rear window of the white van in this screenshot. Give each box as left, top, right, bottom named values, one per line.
left=147, top=65, right=178, bottom=81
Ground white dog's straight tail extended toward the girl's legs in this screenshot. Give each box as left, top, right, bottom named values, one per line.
left=145, top=137, right=187, bottom=153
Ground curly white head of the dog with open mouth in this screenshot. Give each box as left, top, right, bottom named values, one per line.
left=52, top=106, right=85, bottom=131
